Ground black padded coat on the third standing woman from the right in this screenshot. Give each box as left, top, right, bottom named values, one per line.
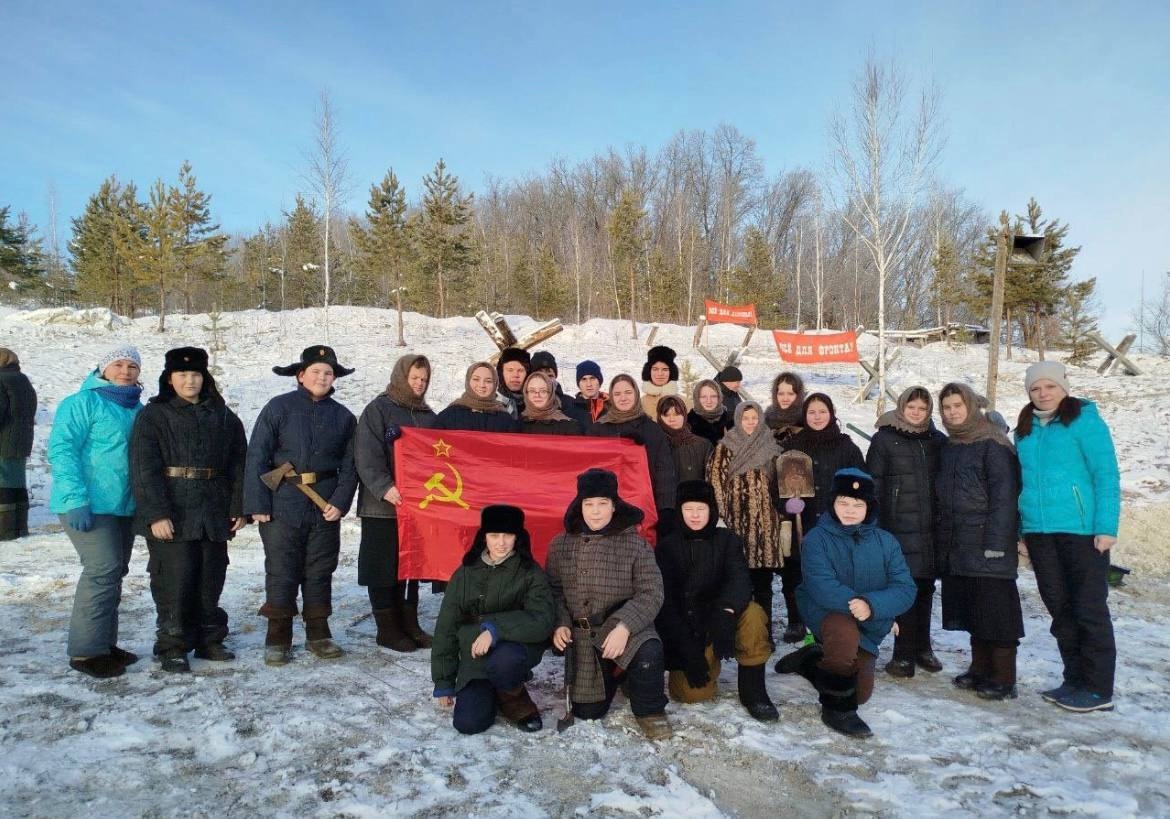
left=866, top=426, right=947, bottom=580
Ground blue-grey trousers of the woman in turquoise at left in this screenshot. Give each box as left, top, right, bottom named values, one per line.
left=61, top=515, right=135, bottom=658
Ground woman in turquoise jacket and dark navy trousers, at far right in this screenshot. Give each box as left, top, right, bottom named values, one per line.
left=1016, top=362, right=1121, bottom=713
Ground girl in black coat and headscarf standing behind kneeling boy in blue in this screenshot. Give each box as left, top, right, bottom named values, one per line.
left=780, top=392, right=866, bottom=642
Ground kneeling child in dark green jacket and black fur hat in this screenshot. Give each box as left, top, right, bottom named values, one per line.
left=431, top=505, right=556, bottom=734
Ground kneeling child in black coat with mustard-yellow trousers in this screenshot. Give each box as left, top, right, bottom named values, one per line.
left=654, top=482, right=779, bottom=722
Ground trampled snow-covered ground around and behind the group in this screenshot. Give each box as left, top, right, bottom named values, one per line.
left=0, top=308, right=1170, bottom=817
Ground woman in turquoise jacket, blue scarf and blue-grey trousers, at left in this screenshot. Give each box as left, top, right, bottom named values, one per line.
left=49, top=345, right=142, bottom=679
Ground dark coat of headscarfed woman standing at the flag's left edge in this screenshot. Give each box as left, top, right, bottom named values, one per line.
left=353, top=393, right=439, bottom=517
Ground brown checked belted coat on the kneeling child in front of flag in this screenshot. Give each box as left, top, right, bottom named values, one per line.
left=545, top=505, right=662, bottom=703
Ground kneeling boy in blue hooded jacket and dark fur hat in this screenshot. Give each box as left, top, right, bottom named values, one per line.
left=776, top=469, right=916, bottom=738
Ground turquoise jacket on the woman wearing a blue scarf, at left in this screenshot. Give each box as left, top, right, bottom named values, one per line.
left=49, top=372, right=142, bottom=516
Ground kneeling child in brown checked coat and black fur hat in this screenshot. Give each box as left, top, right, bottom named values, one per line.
left=548, top=469, right=672, bottom=739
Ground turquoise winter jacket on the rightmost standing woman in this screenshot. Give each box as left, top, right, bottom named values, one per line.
left=1016, top=399, right=1121, bottom=537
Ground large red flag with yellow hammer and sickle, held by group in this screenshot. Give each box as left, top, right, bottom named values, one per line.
left=394, top=427, right=658, bottom=580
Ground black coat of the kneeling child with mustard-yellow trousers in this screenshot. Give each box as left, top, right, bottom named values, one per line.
left=654, top=524, right=751, bottom=670
